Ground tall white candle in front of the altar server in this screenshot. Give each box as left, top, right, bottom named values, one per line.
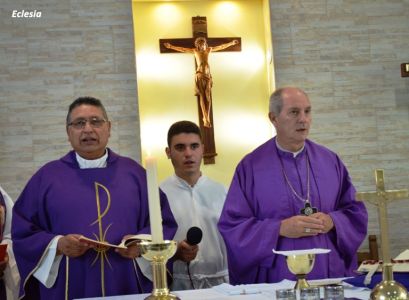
left=145, top=156, right=163, bottom=243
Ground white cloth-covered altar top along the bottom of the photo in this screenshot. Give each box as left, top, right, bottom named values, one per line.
left=75, top=278, right=371, bottom=300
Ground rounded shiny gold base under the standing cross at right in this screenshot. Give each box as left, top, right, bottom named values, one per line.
left=370, top=263, right=409, bottom=300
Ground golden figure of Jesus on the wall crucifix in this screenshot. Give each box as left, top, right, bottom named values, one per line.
left=164, top=37, right=239, bottom=127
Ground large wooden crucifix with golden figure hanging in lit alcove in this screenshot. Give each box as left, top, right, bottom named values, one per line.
left=159, top=16, right=241, bottom=164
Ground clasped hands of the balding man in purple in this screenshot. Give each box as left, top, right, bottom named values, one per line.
left=280, top=215, right=325, bottom=238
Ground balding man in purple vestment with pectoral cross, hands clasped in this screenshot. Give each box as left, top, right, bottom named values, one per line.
left=218, top=87, right=368, bottom=284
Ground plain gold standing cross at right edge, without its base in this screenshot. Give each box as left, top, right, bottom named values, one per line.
left=356, top=169, right=409, bottom=263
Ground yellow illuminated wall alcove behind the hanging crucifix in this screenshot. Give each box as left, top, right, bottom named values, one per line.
left=133, top=0, right=274, bottom=186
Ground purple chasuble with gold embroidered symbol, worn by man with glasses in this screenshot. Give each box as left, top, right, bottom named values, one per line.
left=12, top=149, right=177, bottom=300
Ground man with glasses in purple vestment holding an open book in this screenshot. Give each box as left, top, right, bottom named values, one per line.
left=12, top=97, right=177, bottom=300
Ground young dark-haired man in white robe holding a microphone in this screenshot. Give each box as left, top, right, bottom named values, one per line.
left=160, top=121, right=228, bottom=290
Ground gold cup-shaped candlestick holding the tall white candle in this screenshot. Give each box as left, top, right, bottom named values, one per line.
left=139, top=241, right=179, bottom=300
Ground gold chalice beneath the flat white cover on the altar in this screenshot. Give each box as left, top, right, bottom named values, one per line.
left=287, top=254, right=315, bottom=290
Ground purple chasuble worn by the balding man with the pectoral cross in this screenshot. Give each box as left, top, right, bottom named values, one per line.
left=218, top=138, right=368, bottom=284
